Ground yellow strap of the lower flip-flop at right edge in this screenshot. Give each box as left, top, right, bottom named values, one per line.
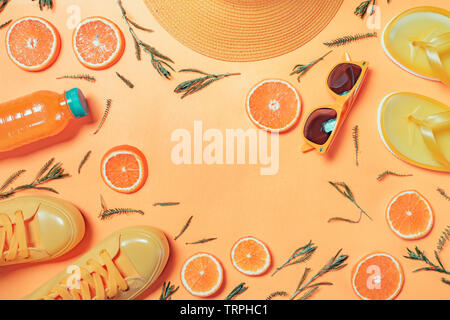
left=420, top=111, right=450, bottom=168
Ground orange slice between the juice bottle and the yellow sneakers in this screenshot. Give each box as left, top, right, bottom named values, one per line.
left=101, top=145, right=148, bottom=193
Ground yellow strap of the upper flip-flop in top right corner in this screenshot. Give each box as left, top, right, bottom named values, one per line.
left=414, top=32, right=450, bottom=85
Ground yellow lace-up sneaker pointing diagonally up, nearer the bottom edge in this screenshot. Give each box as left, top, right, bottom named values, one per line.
left=25, top=226, right=169, bottom=300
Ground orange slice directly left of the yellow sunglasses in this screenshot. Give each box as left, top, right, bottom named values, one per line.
left=247, top=80, right=302, bottom=132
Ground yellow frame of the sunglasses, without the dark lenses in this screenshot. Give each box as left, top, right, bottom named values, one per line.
left=302, top=53, right=369, bottom=154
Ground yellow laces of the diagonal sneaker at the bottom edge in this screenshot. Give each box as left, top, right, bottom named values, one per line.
left=42, top=250, right=128, bottom=300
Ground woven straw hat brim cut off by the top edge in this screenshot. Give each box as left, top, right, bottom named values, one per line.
left=144, top=0, right=343, bottom=61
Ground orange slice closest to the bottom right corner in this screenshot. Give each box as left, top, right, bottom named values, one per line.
left=352, top=253, right=404, bottom=300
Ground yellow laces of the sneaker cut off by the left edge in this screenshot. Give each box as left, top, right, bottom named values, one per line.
left=0, top=211, right=30, bottom=262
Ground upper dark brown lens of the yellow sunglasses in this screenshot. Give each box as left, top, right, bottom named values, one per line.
left=328, top=63, right=362, bottom=96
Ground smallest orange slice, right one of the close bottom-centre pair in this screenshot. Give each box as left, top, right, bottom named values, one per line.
left=231, top=237, right=271, bottom=276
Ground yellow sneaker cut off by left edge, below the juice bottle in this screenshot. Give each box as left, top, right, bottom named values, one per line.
left=0, top=196, right=85, bottom=267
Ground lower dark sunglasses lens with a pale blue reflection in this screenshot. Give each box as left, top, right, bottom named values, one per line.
left=303, top=108, right=337, bottom=145
